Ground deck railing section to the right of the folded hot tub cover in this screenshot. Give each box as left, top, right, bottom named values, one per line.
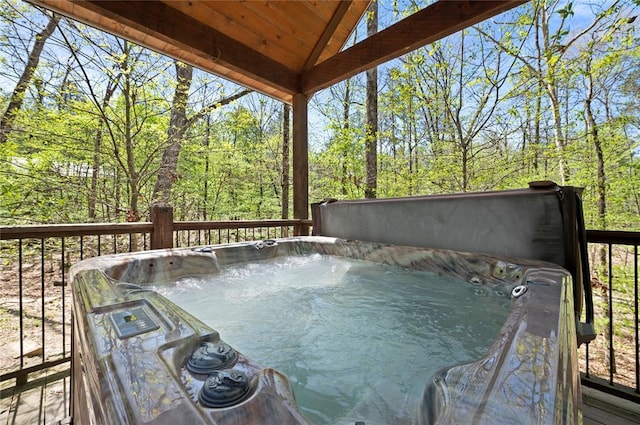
left=580, top=230, right=640, bottom=403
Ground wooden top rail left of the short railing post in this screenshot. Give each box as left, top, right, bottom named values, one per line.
left=0, top=222, right=153, bottom=240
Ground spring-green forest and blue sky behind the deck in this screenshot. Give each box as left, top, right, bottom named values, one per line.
left=0, top=0, right=640, bottom=230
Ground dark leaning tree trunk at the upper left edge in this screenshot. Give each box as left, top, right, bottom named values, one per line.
left=0, top=13, right=60, bottom=143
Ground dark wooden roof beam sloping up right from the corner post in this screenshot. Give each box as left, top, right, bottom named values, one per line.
left=300, top=0, right=527, bottom=95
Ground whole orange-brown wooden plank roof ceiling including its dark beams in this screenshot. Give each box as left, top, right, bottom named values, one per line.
left=30, top=0, right=526, bottom=103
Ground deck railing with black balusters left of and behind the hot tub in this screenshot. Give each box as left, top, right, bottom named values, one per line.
left=0, top=215, right=311, bottom=385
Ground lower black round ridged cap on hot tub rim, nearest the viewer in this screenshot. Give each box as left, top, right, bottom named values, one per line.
left=198, top=369, right=249, bottom=408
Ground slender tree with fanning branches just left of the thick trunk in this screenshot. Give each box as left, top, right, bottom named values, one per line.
left=63, top=33, right=167, bottom=221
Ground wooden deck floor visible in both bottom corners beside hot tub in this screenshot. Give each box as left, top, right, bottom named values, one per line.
left=0, top=364, right=640, bottom=425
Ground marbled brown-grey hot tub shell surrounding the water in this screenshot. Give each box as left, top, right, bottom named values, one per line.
left=71, top=236, right=581, bottom=425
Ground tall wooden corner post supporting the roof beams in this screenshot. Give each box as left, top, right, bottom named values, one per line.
left=293, top=93, right=309, bottom=236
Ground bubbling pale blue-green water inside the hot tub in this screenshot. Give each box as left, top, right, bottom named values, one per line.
left=154, top=254, right=511, bottom=425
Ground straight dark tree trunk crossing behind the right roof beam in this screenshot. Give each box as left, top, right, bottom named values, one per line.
left=364, top=0, right=378, bottom=198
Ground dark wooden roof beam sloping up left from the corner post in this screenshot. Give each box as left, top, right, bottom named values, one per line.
left=76, top=0, right=297, bottom=94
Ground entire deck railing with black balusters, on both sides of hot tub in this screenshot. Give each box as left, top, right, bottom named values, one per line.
left=0, top=220, right=640, bottom=402
